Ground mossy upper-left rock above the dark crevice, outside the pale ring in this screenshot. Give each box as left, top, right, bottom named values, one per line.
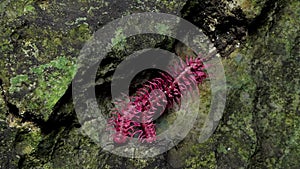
left=0, top=0, right=184, bottom=121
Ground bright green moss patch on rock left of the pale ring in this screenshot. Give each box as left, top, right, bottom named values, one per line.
left=9, top=57, right=76, bottom=120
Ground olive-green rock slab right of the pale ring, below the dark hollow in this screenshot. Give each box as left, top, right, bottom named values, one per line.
left=182, top=1, right=300, bottom=168
